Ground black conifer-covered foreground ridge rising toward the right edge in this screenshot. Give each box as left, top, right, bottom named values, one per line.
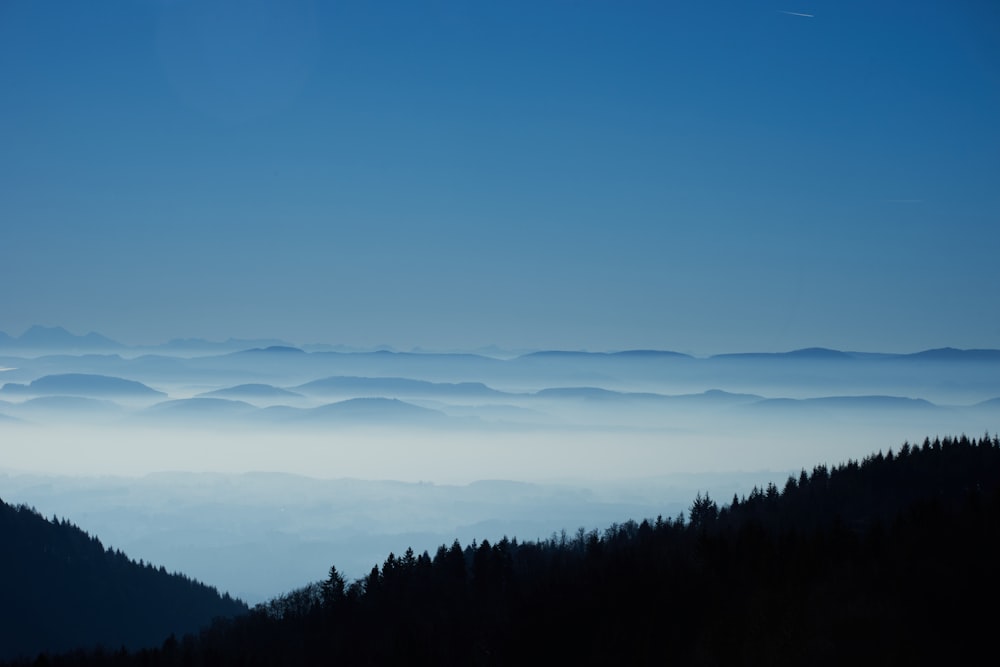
left=1, top=436, right=1000, bottom=665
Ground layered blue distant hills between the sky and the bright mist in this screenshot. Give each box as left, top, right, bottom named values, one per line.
left=0, top=327, right=1000, bottom=433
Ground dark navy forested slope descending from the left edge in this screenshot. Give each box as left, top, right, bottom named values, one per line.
left=0, top=502, right=246, bottom=659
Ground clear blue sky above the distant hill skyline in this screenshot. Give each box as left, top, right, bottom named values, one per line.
left=0, top=0, right=1000, bottom=354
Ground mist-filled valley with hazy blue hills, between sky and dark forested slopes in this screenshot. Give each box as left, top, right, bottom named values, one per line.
left=0, top=328, right=1000, bottom=602
